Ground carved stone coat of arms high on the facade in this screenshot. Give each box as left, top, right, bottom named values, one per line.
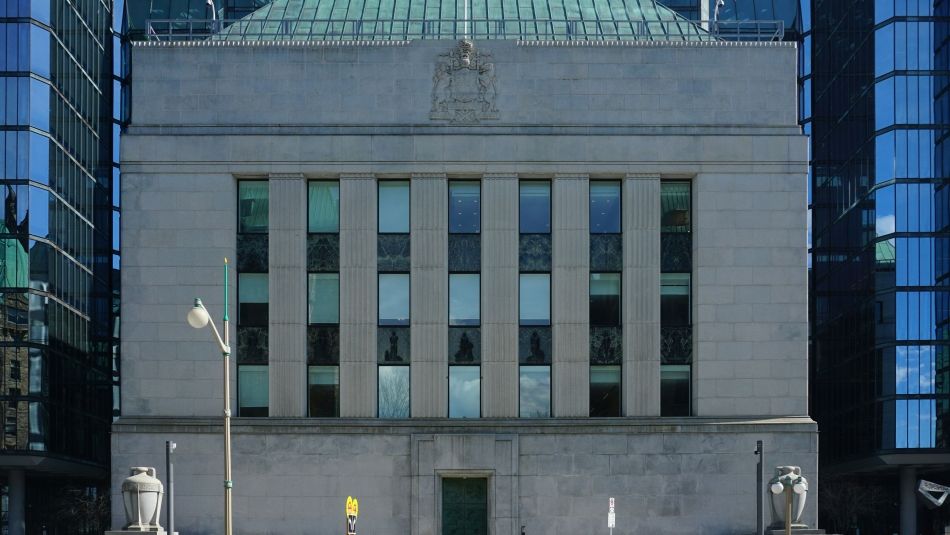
left=429, top=39, right=498, bottom=123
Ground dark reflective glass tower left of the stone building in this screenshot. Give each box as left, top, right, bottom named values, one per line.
left=0, top=0, right=121, bottom=535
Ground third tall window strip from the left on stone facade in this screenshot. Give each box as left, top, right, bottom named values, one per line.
left=376, top=180, right=411, bottom=418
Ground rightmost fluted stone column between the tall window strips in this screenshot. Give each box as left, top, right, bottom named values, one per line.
left=622, top=175, right=660, bottom=416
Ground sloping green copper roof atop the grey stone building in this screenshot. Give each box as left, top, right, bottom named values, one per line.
left=213, top=0, right=715, bottom=41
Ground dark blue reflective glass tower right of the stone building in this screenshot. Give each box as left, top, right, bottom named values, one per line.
left=802, top=0, right=950, bottom=533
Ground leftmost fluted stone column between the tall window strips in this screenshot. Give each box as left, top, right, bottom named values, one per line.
left=267, top=174, right=307, bottom=416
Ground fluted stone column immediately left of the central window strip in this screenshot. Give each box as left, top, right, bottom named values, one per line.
left=409, top=174, right=449, bottom=418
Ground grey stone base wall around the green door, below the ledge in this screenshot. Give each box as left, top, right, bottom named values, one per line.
left=112, top=418, right=818, bottom=535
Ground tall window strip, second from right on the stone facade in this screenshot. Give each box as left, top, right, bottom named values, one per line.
left=589, top=181, right=623, bottom=416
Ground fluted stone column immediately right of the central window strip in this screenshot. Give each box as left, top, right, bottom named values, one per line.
left=481, top=173, right=518, bottom=418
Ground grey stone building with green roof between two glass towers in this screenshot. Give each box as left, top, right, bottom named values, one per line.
left=113, top=0, right=817, bottom=535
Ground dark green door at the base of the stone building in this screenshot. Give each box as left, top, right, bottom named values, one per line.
left=442, top=477, right=488, bottom=535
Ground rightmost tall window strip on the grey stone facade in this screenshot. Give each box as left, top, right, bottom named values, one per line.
left=660, top=181, right=693, bottom=416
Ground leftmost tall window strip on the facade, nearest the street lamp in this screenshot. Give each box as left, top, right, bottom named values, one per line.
left=235, top=180, right=270, bottom=416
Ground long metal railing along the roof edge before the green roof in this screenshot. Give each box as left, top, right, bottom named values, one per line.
left=147, top=18, right=785, bottom=42
